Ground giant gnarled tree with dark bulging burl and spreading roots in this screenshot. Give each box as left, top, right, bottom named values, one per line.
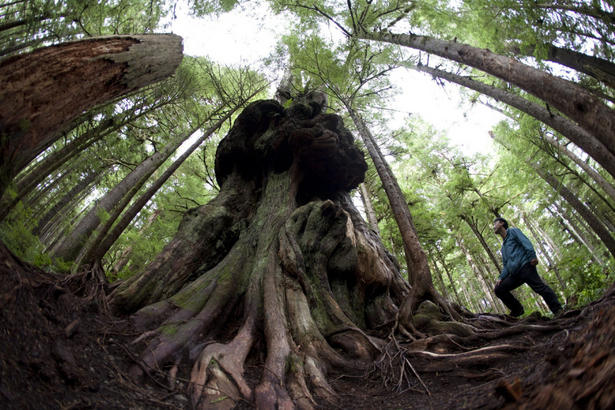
left=111, top=100, right=409, bottom=408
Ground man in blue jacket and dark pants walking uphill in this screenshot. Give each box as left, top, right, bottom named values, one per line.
left=493, top=218, right=562, bottom=317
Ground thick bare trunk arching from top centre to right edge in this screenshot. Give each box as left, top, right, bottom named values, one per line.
left=355, top=30, right=615, bottom=158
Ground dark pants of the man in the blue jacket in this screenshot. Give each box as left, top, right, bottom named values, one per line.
left=494, top=263, right=562, bottom=316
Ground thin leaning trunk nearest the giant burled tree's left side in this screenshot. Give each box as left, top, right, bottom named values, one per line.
left=75, top=113, right=231, bottom=265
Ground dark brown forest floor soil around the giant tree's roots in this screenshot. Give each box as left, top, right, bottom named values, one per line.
left=0, top=244, right=615, bottom=409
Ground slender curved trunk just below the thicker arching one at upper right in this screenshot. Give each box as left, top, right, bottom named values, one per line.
left=415, top=65, right=615, bottom=178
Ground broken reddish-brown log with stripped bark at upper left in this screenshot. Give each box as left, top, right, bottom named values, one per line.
left=0, top=34, right=182, bottom=196
